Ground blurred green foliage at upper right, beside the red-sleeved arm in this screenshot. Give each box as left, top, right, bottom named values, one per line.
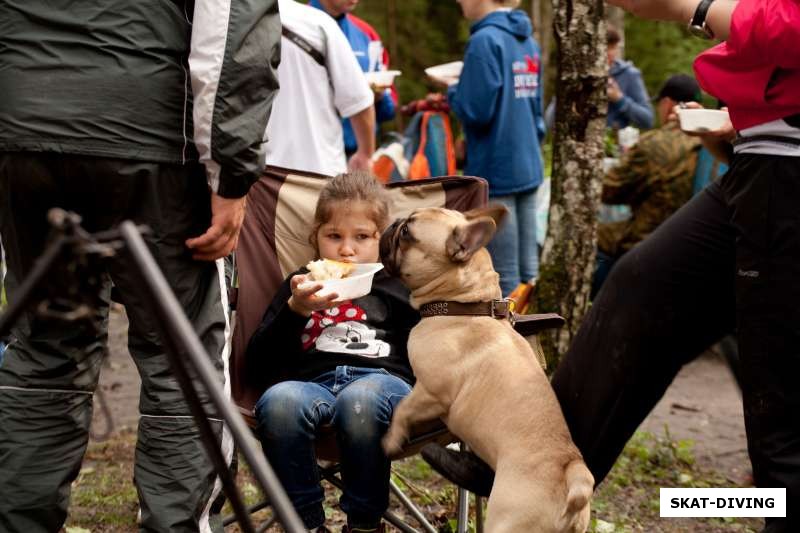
left=625, top=15, right=710, bottom=102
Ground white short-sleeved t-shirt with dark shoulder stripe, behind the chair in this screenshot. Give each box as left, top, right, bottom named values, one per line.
left=266, top=0, right=374, bottom=176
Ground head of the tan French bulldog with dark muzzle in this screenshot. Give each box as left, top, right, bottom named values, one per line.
left=380, top=205, right=506, bottom=291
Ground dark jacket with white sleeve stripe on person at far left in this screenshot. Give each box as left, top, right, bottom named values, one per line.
left=0, top=0, right=281, bottom=198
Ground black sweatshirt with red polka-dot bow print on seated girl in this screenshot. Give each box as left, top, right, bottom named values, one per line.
left=246, top=269, right=419, bottom=388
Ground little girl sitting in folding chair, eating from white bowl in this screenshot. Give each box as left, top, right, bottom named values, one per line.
left=247, top=173, right=419, bottom=533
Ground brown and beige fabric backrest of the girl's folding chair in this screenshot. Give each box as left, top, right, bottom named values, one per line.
left=230, top=167, right=489, bottom=414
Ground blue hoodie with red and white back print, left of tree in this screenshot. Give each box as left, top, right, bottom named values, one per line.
left=447, top=10, right=545, bottom=196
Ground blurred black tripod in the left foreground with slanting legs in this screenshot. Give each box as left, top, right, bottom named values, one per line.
left=0, top=209, right=306, bottom=533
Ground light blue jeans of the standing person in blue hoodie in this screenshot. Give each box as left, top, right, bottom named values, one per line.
left=487, top=189, right=539, bottom=296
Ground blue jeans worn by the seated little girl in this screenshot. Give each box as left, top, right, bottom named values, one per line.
left=255, top=366, right=411, bottom=529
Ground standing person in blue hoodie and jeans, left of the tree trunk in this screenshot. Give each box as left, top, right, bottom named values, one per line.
left=447, top=0, right=545, bottom=295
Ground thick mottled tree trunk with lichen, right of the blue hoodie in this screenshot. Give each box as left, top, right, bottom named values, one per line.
left=536, top=0, right=608, bottom=369
